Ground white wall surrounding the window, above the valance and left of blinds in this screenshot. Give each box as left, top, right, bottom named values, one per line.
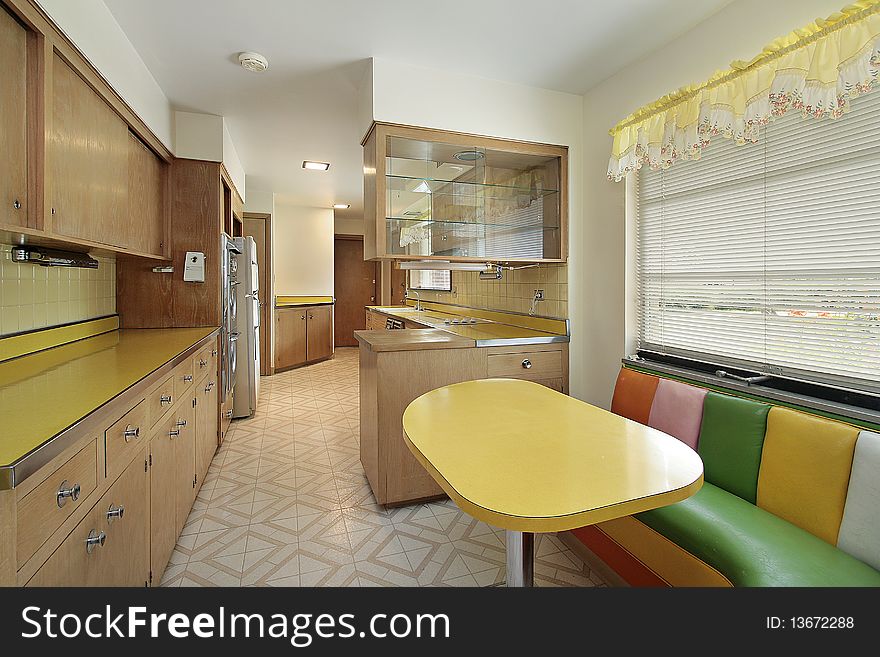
left=570, top=0, right=843, bottom=406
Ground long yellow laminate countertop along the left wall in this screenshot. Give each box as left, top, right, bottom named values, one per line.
left=0, top=328, right=217, bottom=467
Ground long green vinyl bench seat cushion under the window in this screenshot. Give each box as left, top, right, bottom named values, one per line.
left=636, top=483, right=880, bottom=586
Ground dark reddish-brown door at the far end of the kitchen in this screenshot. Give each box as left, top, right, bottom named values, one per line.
left=333, top=235, right=377, bottom=347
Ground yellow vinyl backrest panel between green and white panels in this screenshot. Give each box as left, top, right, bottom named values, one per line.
left=758, top=406, right=859, bottom=545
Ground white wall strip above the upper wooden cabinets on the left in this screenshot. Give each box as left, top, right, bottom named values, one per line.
left=38, top=0, right=174, bottom=150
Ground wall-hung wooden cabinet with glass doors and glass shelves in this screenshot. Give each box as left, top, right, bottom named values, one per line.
left=363, top=123, right=568, bottom=262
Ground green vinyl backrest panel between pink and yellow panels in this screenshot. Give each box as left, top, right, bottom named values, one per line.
left=697, top=392, right=770, bottom=504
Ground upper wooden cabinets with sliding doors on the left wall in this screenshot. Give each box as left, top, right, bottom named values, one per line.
left=0, top=0, right=172, bottom=260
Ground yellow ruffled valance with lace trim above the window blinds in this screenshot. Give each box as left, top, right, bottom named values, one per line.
left=608, top=0, right=880, bottom=181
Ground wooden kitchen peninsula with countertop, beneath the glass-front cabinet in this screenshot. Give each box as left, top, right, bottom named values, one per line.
left=355, top=303, right=569, bottom=506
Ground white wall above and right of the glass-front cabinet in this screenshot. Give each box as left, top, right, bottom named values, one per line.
left=372, top=58, right=589, bottom=397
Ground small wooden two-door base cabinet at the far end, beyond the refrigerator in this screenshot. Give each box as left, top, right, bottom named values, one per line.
left=275, top=305, right=333, bottom=371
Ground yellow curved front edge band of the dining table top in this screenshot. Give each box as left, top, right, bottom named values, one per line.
left=403, top=392, right=703, bottom=534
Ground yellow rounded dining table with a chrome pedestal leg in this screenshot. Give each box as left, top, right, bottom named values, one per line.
left=403, top=379, right=703, bottom=586
